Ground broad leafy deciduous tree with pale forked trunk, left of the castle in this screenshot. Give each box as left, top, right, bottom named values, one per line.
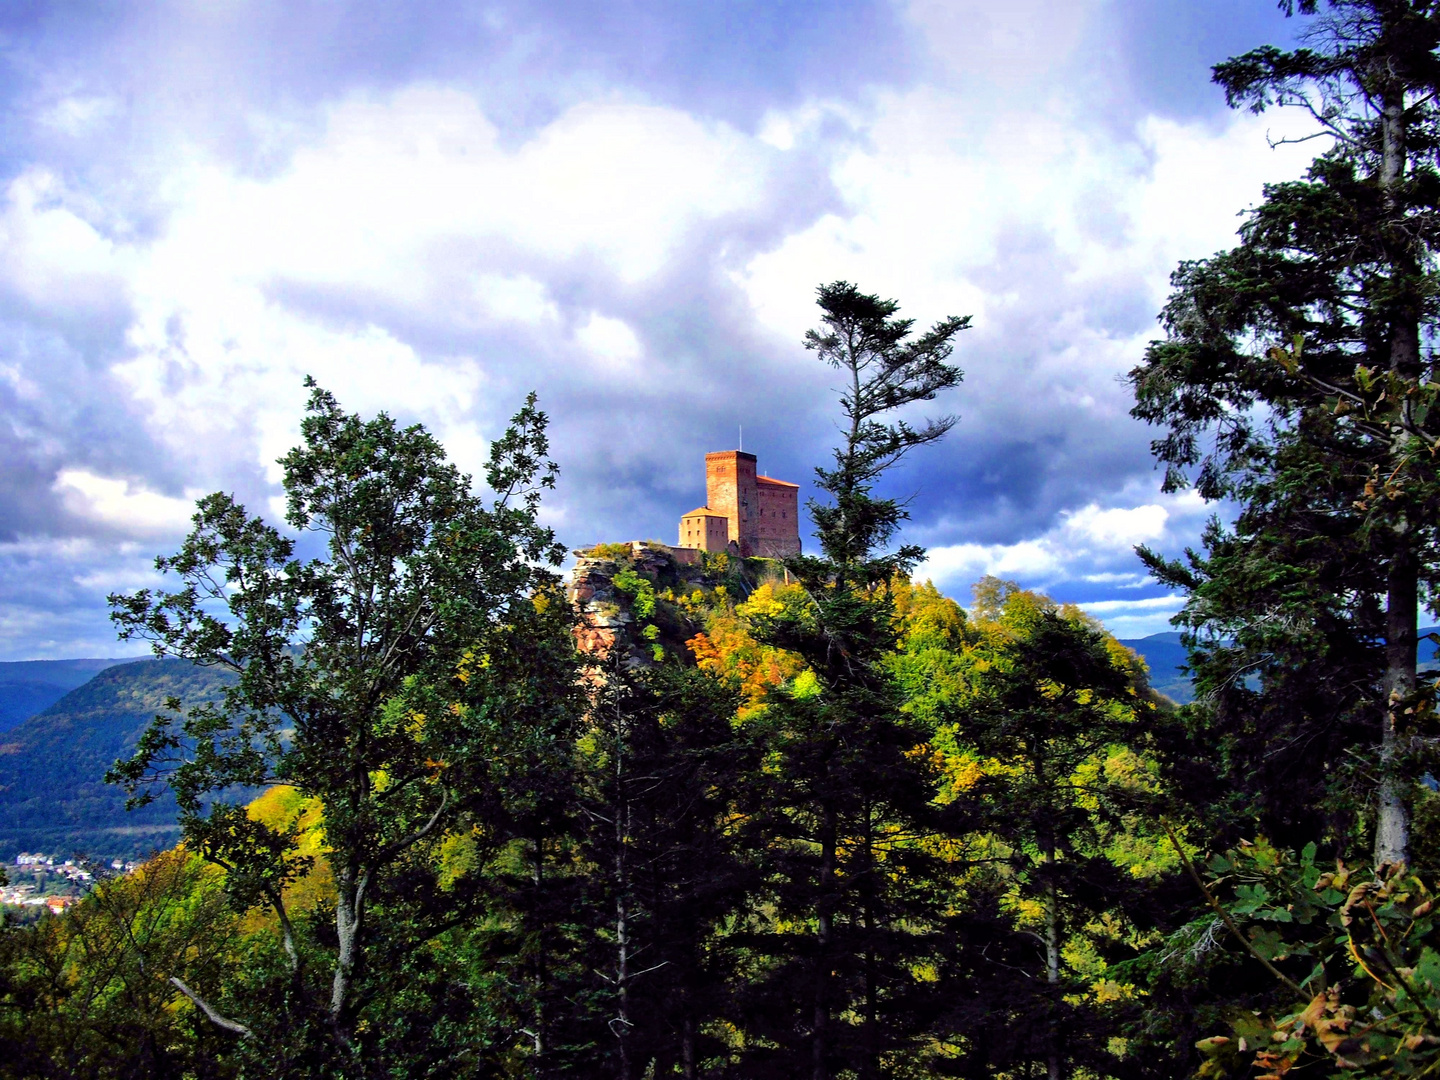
left=102, top=382, right=575, bottom=1068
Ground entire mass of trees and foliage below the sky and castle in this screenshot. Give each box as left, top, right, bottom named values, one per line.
left=14, top=0, right=1440, bottom=1080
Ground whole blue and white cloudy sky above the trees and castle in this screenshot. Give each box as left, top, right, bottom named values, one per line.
left=0, top=0, right=1313, bottom=660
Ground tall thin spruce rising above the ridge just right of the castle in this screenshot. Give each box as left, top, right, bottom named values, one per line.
left=747, top=282, right=969, bottom=1080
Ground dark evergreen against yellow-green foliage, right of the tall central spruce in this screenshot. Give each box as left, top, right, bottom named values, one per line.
left=956, top=590, right=1153, bottom=1080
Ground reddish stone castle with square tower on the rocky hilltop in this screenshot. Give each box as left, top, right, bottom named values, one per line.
left=678, top=451, right=801, bottom=559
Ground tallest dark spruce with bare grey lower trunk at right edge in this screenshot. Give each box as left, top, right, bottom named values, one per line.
left=1132, top=0, right=1440, bottom=863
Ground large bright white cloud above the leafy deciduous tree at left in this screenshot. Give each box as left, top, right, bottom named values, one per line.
left=0, top=85, right=776, bottom=504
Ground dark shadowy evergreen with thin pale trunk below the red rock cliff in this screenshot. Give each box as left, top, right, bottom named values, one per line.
left=582, top=664, right=759, bottom=1080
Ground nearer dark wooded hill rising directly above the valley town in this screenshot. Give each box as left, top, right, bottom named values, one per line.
left=0, top=660, right=225, bottom=861
